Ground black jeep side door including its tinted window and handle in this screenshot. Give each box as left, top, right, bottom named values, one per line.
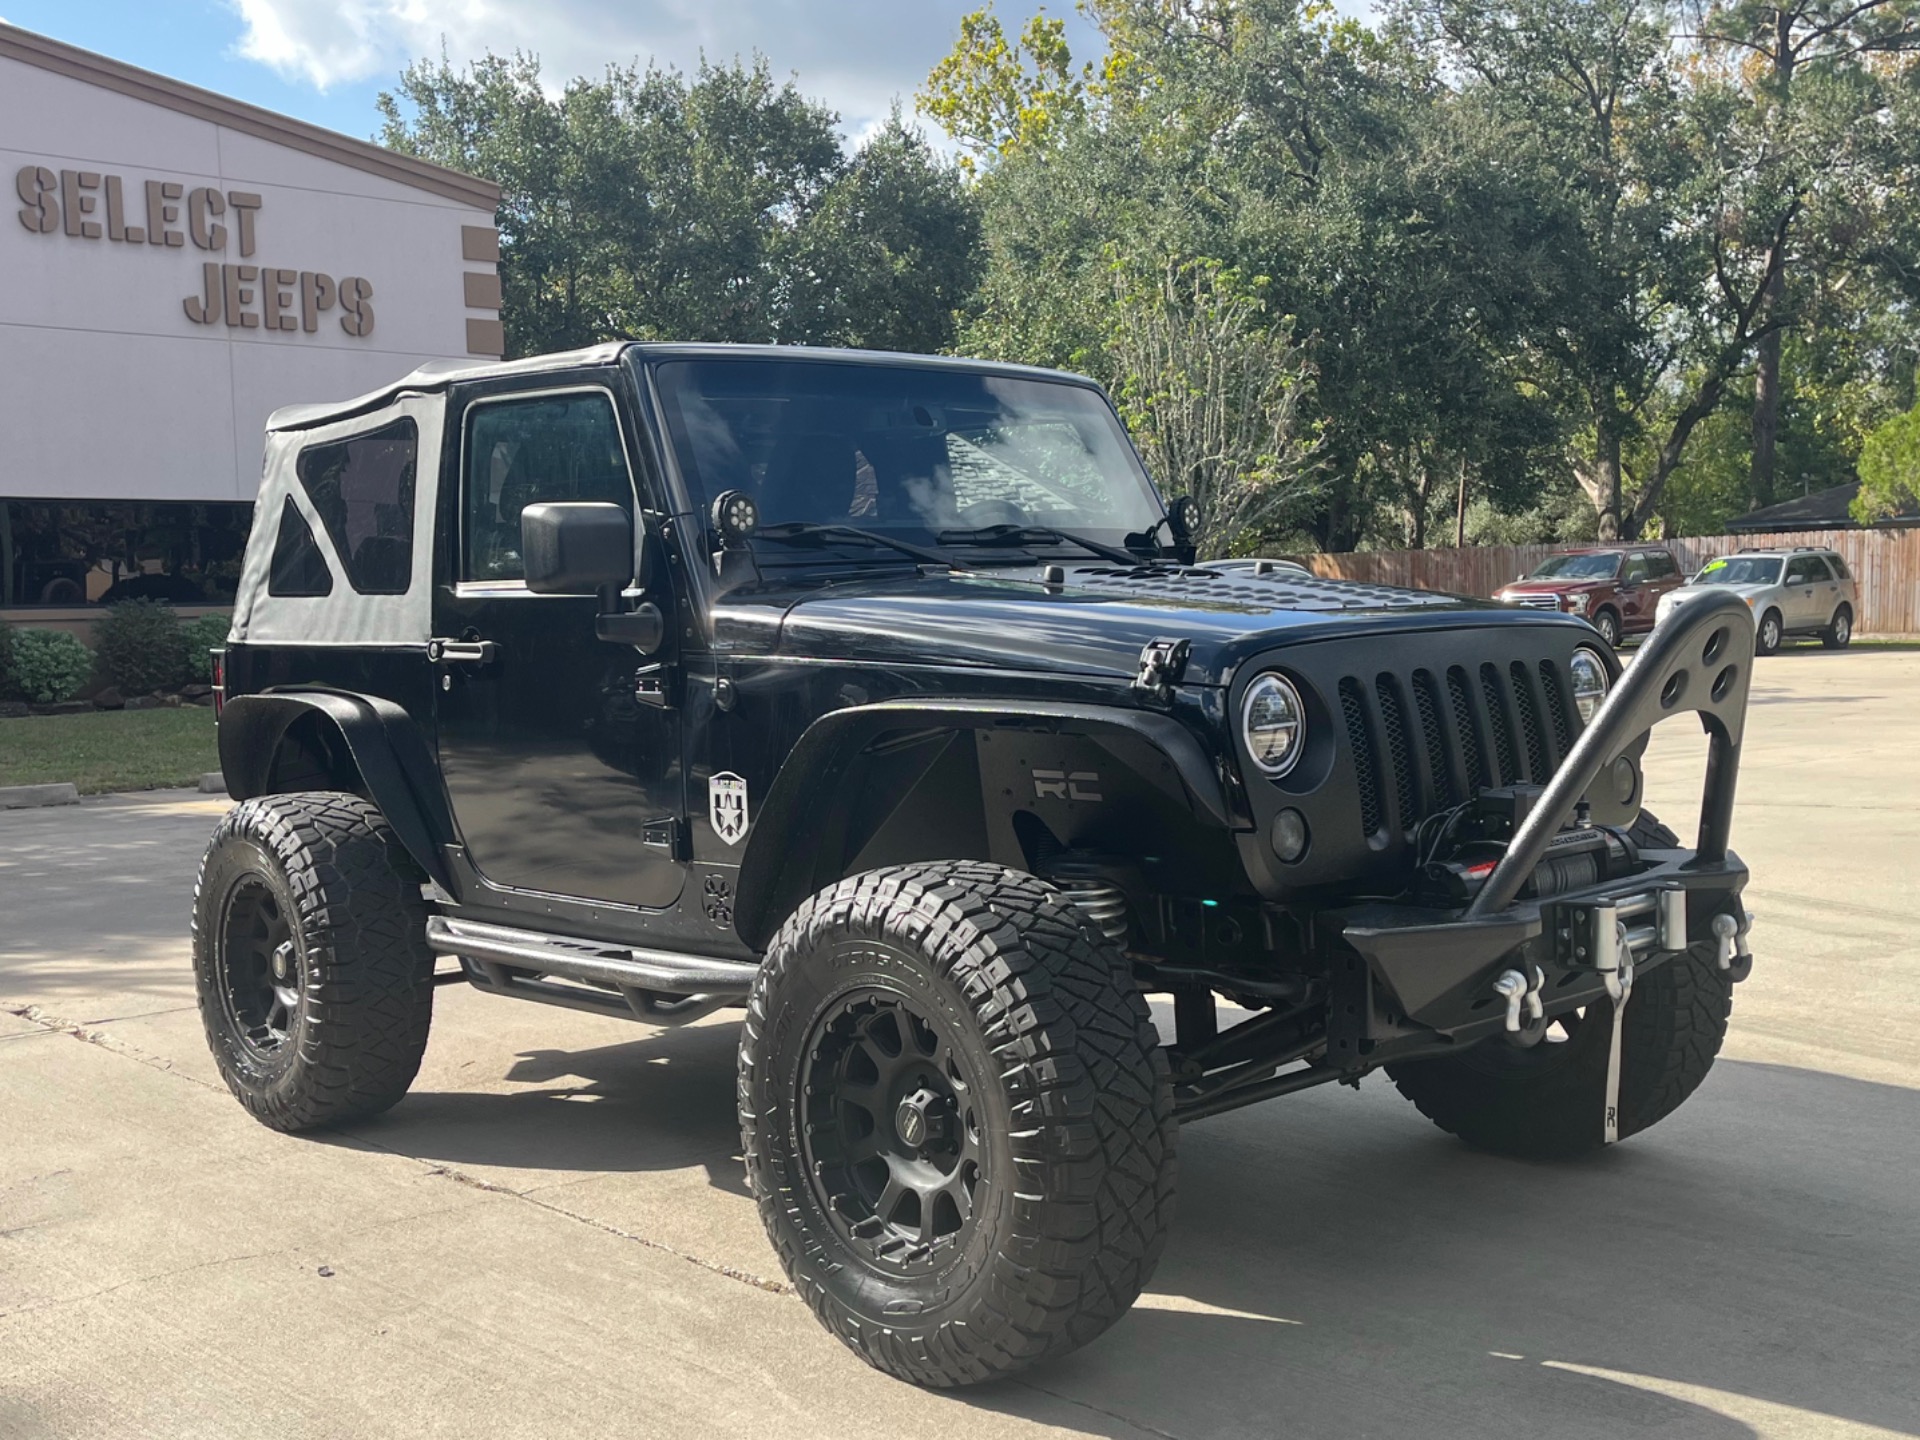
left=434, top=371, right=685, bottom=906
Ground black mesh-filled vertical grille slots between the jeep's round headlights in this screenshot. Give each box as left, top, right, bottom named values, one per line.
left=1338, top=660, right=1578, bottom=839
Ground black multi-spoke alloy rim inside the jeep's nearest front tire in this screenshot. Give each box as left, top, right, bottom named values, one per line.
left=797, top=989, right=991, bottom=1275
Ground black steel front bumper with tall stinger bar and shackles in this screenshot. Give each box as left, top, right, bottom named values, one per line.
left=1325, top=595, right=1753, bottom=1066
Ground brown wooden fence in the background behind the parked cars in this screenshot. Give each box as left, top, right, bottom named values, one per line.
left=1298, top=528, right=1920, bottom=636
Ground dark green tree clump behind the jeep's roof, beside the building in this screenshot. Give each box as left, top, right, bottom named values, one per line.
left=380, top=56, right=973, bottom=353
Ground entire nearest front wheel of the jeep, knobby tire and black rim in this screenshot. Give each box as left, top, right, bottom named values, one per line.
left=739, top=862, right=1175, bottom=1386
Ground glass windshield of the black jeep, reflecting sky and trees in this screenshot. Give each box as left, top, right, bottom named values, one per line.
left=655, top=359, right=1164, bottom=559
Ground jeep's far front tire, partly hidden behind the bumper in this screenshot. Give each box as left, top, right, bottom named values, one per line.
left=1386, top=814, right=1734, bottom=1160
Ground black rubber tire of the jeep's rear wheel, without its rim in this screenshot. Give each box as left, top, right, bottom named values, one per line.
left=192, top=791, right=434, bottom=1131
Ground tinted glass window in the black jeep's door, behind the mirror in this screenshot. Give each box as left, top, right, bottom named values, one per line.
left=461, top=394, right=634, bottom=580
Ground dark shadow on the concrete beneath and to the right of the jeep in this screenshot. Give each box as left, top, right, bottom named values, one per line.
left=342, top=1025, right=1920, bottom=1440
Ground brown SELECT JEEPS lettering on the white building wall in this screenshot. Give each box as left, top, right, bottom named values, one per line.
left=13, top=165, right=372, bottom=338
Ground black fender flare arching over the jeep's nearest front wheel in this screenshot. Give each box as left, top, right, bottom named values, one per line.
left=733, top=699, right=1236, bottom=950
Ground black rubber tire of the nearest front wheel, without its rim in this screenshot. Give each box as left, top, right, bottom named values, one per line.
left=739, top=862, right=1175, bottom=1386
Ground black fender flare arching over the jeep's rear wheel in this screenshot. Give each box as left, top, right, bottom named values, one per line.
left=219, top=689, right=457, bottom=895
